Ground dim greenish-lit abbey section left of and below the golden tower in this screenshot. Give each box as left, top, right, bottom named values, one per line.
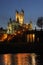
left=7, top=20, right=20, bottom=34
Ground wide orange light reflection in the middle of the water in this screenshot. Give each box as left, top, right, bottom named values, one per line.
left=16, top=53, right=31, bottom=65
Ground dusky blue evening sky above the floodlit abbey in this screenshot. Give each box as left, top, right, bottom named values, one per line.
left=0, top=0, right=43, bottom=28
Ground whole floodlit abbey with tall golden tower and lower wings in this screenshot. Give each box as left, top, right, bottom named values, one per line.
left=7, top=10, right=32, bottom=34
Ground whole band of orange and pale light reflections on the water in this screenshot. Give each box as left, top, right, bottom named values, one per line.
left=1, top=53, right=36, bottom=65
